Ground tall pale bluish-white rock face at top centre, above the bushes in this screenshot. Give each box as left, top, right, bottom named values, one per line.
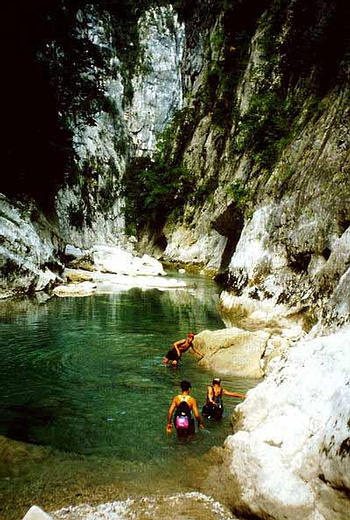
left=125, top=5, right=185, bottom=156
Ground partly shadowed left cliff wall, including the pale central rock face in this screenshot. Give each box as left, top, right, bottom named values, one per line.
left=0, top=2, right=184, bottom=296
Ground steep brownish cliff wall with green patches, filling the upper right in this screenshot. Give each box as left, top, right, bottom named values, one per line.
left=165, top=2, right=350, bottom=332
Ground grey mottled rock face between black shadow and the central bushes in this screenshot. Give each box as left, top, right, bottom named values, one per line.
left=56, top=6, right=127, bottom=248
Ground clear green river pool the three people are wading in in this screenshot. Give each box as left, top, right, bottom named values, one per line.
left=0, top=276, right=256, bottom=519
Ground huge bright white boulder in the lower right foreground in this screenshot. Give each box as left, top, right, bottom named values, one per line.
left=208, top=327, right=350, bottom=520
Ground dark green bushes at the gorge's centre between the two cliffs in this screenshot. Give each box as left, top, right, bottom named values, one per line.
left=123, top=103, right=198, bottom=234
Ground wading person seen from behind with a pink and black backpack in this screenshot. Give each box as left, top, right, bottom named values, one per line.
left=166, top=381, right=204, bottom=437
